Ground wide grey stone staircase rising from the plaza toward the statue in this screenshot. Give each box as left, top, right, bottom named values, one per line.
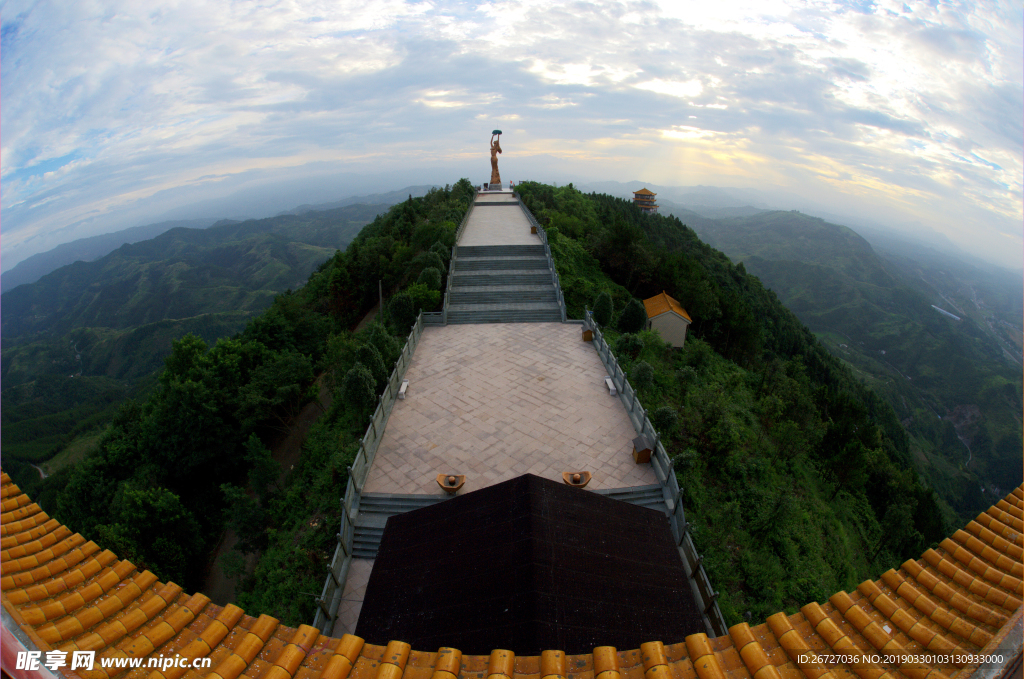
left=447, top=245, right=562, bottom=324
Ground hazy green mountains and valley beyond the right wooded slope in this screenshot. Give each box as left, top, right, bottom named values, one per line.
left=655, top=205, right=1022, bottom=518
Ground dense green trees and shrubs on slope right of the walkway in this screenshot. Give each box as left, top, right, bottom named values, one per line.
left=519, top=182, right=946, bottom=624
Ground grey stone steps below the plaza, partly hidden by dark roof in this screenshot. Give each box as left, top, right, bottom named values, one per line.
left=352, top=485, right=669, bottom=559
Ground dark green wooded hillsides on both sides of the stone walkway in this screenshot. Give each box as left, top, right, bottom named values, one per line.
left=8, top=180, right=974, bottom=624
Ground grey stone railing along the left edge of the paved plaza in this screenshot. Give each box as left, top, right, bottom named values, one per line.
left=313, top=312, right=426, bottom=635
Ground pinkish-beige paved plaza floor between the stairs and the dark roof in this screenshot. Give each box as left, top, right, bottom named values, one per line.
left=365, top=323, right=657, bottom=494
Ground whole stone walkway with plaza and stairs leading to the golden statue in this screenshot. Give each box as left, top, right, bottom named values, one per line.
left=333, top=194, right=662, bottom=636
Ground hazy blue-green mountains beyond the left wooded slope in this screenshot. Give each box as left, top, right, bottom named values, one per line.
left=0, top=205, right=386, bottom=481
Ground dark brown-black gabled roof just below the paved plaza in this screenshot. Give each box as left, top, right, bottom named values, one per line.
left=355, top=474, right=703, bottom=654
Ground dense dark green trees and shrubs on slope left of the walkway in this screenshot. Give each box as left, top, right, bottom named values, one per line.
left=29, top=180, right=472, bottom=625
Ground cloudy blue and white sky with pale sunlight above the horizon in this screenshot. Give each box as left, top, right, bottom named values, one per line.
left=0, top=0, right=1024, bottom=269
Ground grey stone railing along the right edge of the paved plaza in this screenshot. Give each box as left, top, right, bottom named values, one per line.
left=584, top=310, right=728, bottom=636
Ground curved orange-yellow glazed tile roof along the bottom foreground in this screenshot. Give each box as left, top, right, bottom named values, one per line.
left=0, top=473, right=1024, bottom=679
